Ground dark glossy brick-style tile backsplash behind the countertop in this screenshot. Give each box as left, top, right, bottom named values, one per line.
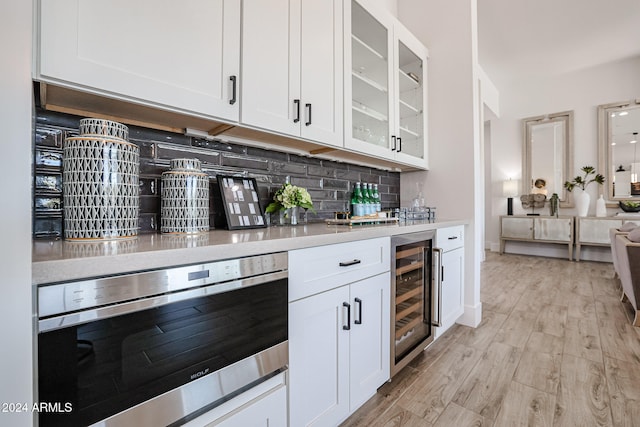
left=33, top=108, right=400, bottom=238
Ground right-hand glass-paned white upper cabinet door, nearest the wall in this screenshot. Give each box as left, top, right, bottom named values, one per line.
left=391, top=25, right=428, bottom=168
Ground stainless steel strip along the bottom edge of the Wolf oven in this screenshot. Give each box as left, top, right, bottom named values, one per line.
left=91, top=341, right=289, bottom=427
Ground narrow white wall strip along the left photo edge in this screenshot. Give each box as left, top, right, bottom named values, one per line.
left=0, top=0, right=33, bottom=426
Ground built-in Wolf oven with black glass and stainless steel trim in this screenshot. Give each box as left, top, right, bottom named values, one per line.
left=37, top=253, right=288, bottom=427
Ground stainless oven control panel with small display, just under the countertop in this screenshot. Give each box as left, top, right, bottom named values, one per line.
left=38, top=252, right=288, bottom=318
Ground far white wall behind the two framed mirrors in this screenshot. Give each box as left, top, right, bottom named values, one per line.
left=486, top=58, right=640, bottom=257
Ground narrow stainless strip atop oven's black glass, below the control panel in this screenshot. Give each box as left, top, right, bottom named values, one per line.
left=38, top=271, right=288, bottom=332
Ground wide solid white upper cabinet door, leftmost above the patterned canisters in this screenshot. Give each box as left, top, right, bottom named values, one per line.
left=35, top=0, right=240, bottom=121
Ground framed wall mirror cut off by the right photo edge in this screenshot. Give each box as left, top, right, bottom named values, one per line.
left=598, top=99, right=640, bottom=202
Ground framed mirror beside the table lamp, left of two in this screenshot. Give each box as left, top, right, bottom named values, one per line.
left=521, top=111, right=573, bottom=207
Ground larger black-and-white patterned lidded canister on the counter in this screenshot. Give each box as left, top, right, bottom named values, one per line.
left=62, top=118, right=140, bottom=241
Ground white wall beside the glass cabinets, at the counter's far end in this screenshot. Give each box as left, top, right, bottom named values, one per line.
left=398, top=0, right=484, bottom=326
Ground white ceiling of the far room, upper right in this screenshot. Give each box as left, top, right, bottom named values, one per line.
left=478, top=0, right=640, bottom=87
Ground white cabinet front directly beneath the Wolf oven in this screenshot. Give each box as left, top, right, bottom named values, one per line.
left=185, top=373, right=287, bottom=427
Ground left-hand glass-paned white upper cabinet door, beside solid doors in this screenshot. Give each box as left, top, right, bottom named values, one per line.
left=344, top=0, right=394, bottom=159
